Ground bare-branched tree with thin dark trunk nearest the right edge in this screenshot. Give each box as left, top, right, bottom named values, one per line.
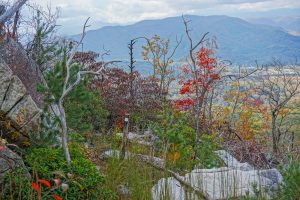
left=255, top=60, right=300, bottom=154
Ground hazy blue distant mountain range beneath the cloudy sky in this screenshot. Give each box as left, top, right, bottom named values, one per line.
left=71, top=15, right=300, bottom=65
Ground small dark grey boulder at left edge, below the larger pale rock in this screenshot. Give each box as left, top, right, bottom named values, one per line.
left=0, top=146, right=31, bottom=183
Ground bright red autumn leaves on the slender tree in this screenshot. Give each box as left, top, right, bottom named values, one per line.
left=175, top=47, right=221, bottom=110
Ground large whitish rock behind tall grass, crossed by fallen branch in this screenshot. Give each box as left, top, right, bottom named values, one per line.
left=152, top=150, right=282, bottom=200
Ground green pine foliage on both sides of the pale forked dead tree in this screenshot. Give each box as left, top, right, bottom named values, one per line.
left=37, top=47, right=108, bottom=133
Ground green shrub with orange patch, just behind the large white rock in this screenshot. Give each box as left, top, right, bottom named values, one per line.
left=151, top=107, right=221, bottom=171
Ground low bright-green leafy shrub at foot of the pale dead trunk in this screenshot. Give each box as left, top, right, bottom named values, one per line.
left=25, top=145, right=114, bottom=200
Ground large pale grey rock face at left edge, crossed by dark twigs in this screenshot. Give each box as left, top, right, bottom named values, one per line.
left=0, top=59, right=40, bottom=143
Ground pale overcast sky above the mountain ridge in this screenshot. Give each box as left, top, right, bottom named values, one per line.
left=30, top=0, right=300, bottom=34
